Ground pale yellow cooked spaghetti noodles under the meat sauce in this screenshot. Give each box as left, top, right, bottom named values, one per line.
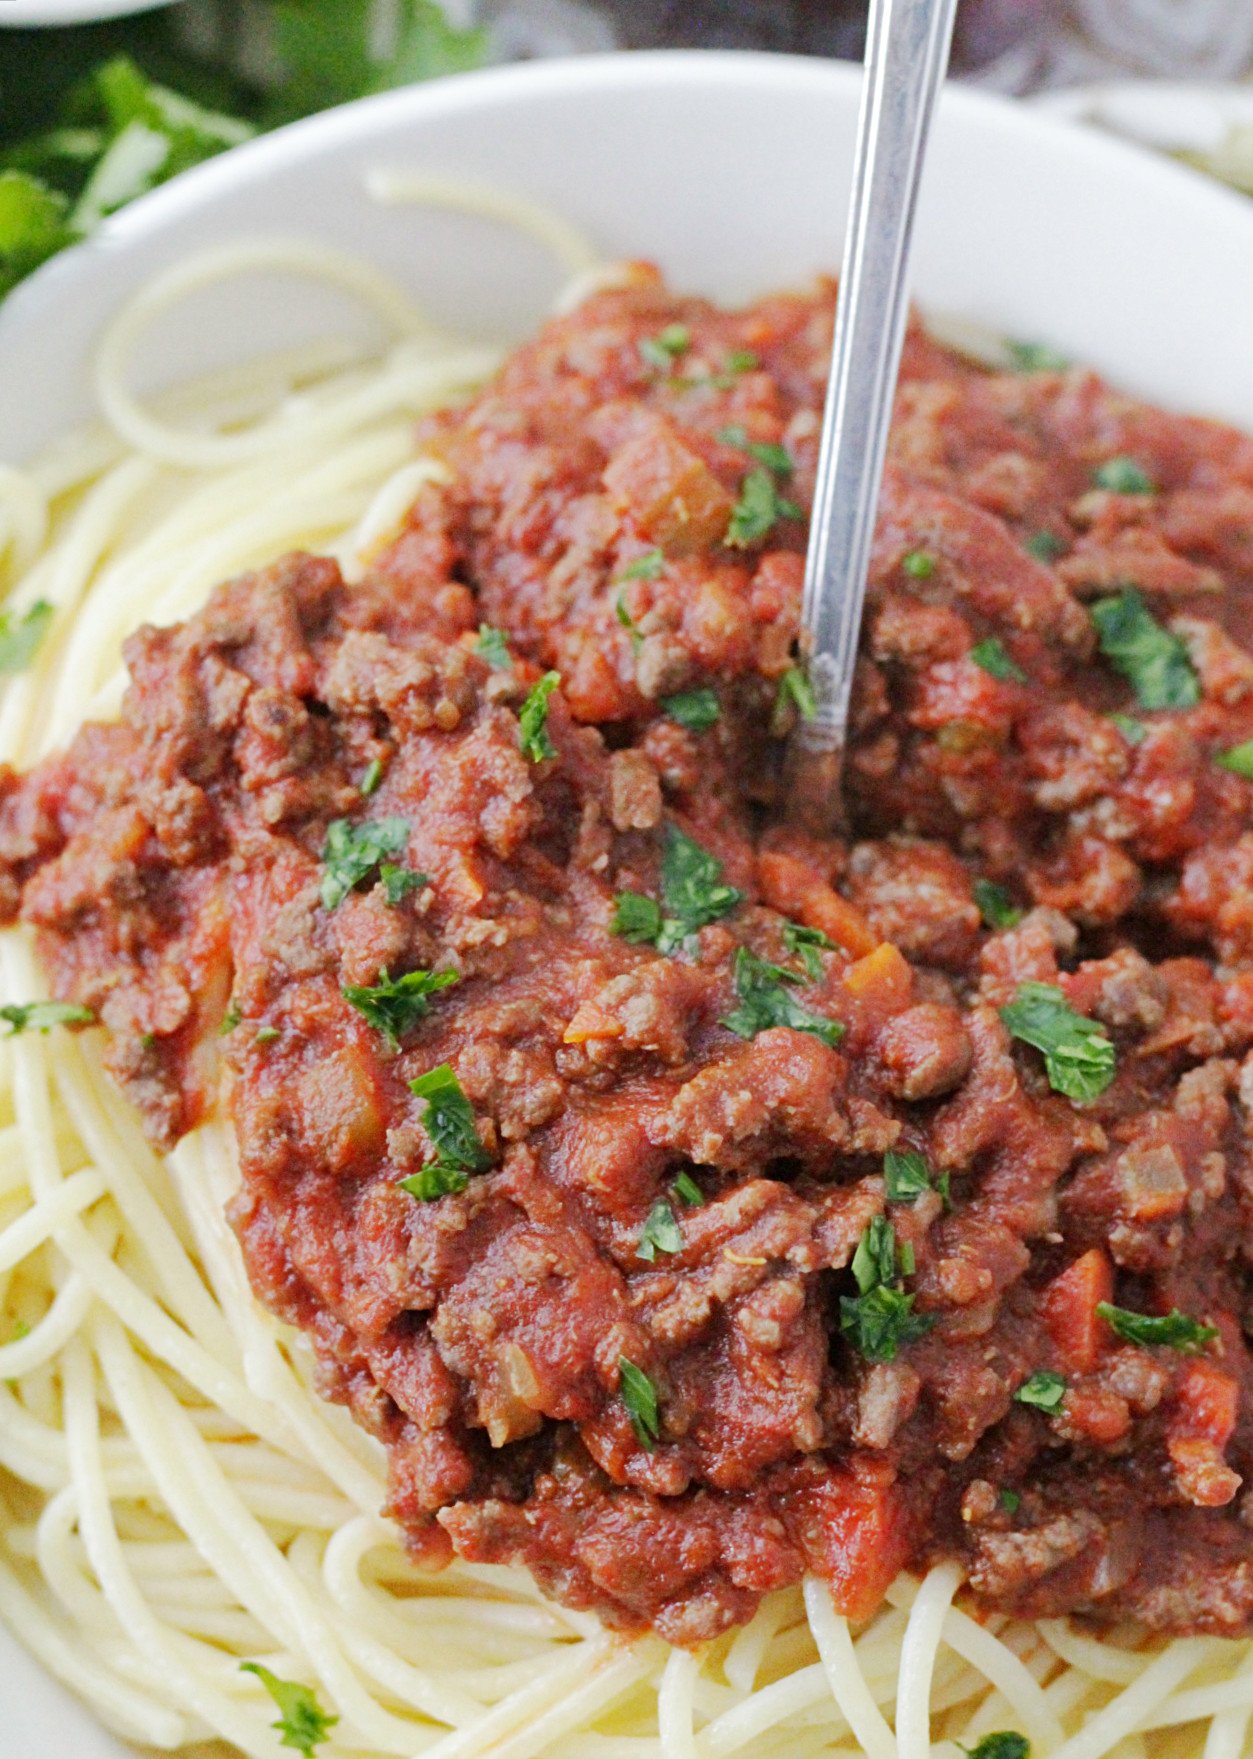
left=0, top=209, right=1253, bottom=1759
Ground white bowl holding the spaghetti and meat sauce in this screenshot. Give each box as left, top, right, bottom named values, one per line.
left=0, top=48, right=1253, bottom=1759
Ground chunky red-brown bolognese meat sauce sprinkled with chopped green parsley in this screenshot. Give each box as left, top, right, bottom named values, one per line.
left=0, top=271, right=1253, bottom=1643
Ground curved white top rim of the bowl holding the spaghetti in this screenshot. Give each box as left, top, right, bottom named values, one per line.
left=0, top=49, right=1253, bottom=343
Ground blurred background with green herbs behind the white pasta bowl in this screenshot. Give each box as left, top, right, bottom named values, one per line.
left=0, top=0, right=1253, bottom=297
